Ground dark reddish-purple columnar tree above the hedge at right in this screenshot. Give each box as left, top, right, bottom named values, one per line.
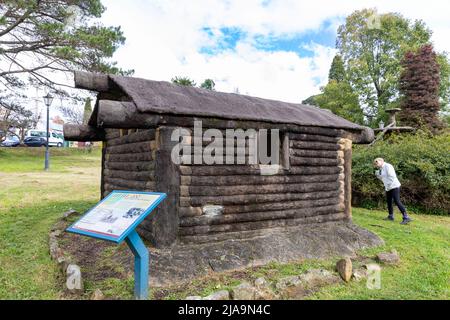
left=400, top=45, right=443, bottom=131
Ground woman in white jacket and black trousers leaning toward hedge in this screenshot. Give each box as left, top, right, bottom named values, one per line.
left=373, top=158, right=412, bottom=224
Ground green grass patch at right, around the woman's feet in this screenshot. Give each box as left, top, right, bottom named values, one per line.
left=311, top=209, right=450, bottom=299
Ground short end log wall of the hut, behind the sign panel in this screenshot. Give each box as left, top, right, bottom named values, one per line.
left=102, top=129, right=156, bottom=197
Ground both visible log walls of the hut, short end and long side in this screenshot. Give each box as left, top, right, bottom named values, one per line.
left=102, top=128, right=351, bottom=246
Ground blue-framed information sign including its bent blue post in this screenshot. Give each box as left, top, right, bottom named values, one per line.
left=66, top=190, right=167, bottom=300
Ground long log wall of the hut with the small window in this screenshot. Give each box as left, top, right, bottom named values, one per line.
left=179, top=127, right=351, bottom=242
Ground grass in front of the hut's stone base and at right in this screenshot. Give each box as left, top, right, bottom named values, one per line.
left=153, top=208, right=450, bottom=300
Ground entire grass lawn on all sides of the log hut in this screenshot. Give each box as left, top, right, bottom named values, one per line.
left=0, top=148, right=450, bottom=299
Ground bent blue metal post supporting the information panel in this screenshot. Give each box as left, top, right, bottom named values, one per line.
left=125, top=230, right=150, bottom=300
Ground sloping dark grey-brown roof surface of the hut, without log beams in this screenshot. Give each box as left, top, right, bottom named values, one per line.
left=109, top=75, right=364, bottom=130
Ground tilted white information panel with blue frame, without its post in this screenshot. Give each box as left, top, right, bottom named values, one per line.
left=67, top=190, right=166, bottom=243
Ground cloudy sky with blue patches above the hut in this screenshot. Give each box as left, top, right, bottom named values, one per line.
left=97, top=0, right=450, bottom=102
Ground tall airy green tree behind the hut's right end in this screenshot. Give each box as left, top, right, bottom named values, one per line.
left=336, top=9, right=449, bottom=125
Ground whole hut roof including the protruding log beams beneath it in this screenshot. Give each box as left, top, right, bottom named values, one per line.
left=65, top=72, right=374, bottom=143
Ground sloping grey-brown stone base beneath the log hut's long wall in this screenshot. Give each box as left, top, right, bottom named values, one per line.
left=149, top=221, right=384, bottom=287
